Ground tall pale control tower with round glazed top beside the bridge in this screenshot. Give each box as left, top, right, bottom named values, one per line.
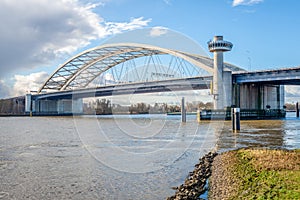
left=208, top=36, right=233, bottom=109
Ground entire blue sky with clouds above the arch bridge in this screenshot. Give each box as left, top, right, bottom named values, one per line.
left=0, top=0, right=300, bottom=102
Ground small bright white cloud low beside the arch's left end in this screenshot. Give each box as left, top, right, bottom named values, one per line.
left=11, top=72, right=49, bottom=96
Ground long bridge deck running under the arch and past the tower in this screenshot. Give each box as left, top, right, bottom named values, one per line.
left=33, top=67, right=300, bottom=100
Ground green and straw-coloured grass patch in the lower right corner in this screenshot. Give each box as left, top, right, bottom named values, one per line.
left=230, top=149, right=300, bottom=199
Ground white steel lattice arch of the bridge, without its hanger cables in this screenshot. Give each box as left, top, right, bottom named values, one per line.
left=38, top=43, right=244, bottom=93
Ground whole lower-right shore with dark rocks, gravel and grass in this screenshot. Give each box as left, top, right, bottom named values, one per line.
left=167, top=148, right=300, bottom=200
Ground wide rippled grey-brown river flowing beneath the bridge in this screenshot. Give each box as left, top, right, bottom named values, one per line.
left=0, top=113, right=300, bottom=199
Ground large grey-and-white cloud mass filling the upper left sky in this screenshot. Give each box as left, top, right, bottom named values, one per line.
left=0, top=0, right=150, bottom=78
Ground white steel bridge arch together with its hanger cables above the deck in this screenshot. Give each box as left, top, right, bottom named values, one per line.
left=38, top=43, right=242, bottom=93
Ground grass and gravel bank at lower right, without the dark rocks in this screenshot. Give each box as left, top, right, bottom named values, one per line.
left=209, top=149, right=300, bottom=199
